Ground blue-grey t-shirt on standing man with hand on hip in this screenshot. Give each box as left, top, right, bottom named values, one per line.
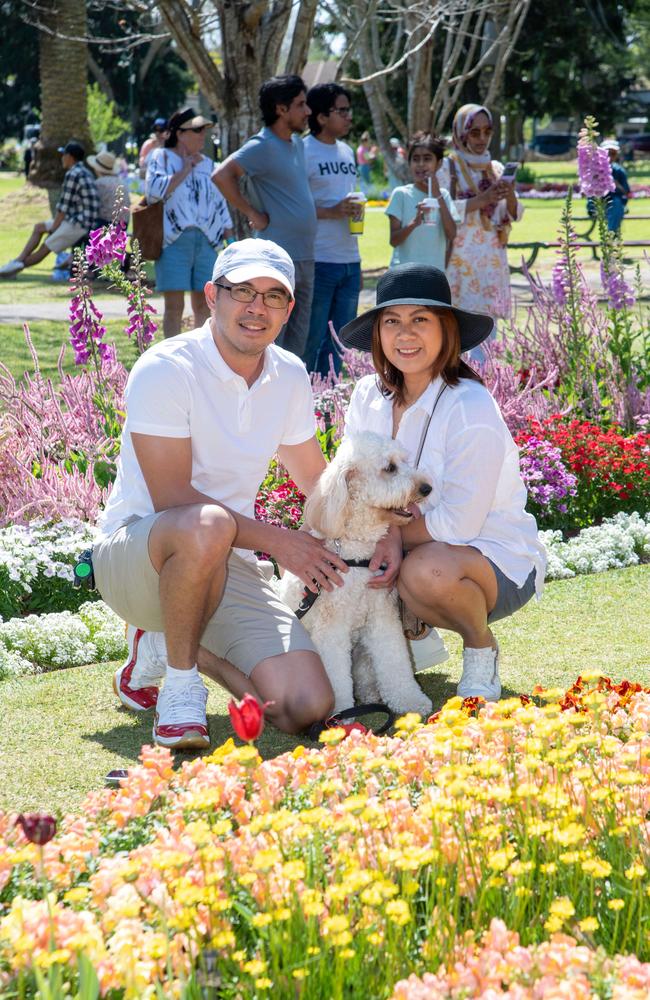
left=232, top=126, right=316, bottom=261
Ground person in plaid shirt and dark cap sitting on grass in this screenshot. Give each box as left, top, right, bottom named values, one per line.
left=0, top=140, right=99, bottom=278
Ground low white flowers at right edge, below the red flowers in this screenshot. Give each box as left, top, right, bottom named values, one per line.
left=540, top=513, right=650, bottom=580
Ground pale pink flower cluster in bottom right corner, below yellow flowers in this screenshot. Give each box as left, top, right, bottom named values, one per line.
left=390, top=919, right=650, bottom=1000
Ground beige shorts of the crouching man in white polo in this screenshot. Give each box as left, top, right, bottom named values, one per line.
left=93, top=514, right=315, bottom=677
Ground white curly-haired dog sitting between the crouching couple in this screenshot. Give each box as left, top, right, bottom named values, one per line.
left=279, top=431, right=432, bottom=715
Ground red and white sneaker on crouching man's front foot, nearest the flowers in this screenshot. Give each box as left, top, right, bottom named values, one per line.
left=153, top=678, right=210, bottom=750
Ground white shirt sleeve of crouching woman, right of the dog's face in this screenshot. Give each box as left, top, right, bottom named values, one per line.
left=424, top=424, right=505, bottom=545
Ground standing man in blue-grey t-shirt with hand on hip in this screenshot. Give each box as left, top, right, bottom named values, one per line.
left=213, top=75, right=316, bottom=358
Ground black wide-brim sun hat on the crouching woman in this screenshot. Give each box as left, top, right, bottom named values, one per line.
left=338, top=264, right=494, bottom=353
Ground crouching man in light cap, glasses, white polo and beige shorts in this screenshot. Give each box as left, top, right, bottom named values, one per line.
left=93, top=239, right=347, bottom=749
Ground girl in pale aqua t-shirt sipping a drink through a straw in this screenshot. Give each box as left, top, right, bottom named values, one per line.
left=386, top=132, right=459, bottom=270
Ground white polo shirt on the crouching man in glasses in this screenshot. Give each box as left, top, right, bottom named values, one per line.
left=99, top=320, right=316, bottom=559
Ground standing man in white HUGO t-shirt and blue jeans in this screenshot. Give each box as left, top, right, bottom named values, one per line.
left=303, top=83, right=361, bottom=375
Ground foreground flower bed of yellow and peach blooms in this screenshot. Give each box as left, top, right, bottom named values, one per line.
left=0, top=677, right=650, bottom=1000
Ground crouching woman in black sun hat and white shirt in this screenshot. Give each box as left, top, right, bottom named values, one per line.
left=339, top=264, right=546, bottom=701
